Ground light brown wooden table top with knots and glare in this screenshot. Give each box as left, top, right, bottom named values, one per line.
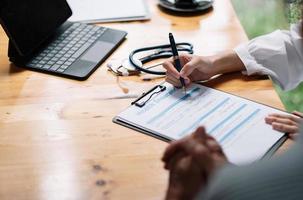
left=0, top=0, right=287, bottom=200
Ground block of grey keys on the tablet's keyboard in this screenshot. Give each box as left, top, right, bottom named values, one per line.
left=27, top=23, right=106, bottom=73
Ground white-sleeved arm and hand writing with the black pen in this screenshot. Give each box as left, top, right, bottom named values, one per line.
left=163, top=23, right=303, bottom=90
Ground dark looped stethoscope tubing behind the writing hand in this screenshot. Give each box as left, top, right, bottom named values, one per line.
left=129, top=42, right=194, bottom=75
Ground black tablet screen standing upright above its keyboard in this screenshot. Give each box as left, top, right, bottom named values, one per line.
left=0, top=0, right=72, bottom=56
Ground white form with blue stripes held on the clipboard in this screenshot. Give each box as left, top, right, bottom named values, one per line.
left=117, top=83, right=285, bottom=164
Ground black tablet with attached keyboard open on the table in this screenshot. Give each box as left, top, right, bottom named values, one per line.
left=0, top=0, right=127, bottom=80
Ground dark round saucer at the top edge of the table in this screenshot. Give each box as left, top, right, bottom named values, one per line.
left=159, top=0, right=214, bottom=13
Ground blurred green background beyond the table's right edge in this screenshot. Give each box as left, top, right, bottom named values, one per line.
left=232, top=0, right=303, bottom=112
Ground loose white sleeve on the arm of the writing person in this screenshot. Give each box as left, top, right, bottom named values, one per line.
left=235, top=23, right=303, bottom=90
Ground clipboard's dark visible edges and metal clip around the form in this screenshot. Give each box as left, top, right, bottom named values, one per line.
left=113, top=84, right=288, bottom=164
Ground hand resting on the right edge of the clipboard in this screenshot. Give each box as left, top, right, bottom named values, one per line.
left=265, top=111, right=303, bottom=138
